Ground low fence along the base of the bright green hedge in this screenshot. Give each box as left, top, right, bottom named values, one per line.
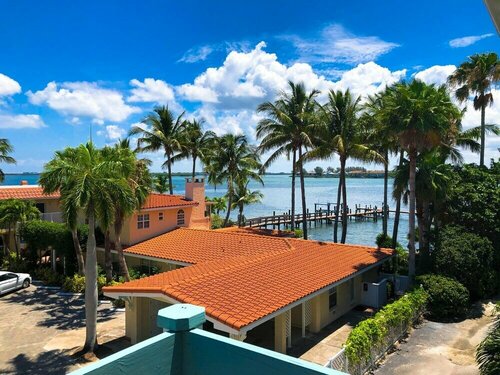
left=325, top=304, right=424, bottom=375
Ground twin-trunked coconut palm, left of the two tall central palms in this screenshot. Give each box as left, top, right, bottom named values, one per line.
left=257, top=81, right=319, bottom=239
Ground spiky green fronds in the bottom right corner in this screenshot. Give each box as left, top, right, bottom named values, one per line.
left=476, top=316, right=500, bottom=375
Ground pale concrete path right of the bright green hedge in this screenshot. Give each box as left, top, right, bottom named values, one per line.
left=374, top=303, right=493, bottom=375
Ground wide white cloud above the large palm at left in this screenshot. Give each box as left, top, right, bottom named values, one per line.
left=27, top=82, right=140, bottom=124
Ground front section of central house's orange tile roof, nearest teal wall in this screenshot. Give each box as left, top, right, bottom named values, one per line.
left=104, top=231, right=393, bottom=330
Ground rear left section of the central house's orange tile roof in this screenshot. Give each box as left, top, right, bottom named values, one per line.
left=125, top=228, right=290, bottom=264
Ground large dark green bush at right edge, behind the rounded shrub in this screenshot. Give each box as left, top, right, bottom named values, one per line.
left=433, top=226, right=495, bottom=300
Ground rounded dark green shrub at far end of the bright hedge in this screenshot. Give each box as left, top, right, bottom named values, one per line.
left=417, top=274, right=469, bottom=321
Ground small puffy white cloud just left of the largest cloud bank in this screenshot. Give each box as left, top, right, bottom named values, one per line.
left=127, top=78, right=175, bottom=104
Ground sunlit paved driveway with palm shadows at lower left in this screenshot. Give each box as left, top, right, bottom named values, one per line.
left=0, top=286, right=127, bottom=374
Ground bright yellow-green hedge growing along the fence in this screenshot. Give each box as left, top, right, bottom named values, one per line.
left=346, top=289, right=428, bottom=365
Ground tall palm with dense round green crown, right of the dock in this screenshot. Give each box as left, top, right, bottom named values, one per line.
left=380, top=80, right=462, bottom=280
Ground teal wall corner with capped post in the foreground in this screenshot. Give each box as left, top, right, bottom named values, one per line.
left=71, top=304, right=345, bottom=375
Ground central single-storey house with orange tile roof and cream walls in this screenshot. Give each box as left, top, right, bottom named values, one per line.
left=103, top=228, right=393, bottom=353
